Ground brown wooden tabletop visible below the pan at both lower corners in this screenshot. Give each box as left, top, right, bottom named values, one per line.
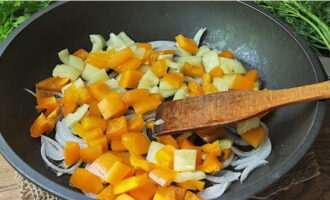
left=0, top=101, right=330, bottom=200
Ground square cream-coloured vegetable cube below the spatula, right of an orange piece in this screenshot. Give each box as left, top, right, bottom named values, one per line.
left=174, top=149, right=197, bottom=171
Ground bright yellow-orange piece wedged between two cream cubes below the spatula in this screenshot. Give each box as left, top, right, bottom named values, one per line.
left=155, top=145, right=176, bottom=169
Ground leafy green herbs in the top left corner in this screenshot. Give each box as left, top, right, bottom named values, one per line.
left=0, top=0, right=50, bottom=43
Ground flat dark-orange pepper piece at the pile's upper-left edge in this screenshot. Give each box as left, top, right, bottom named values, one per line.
left=36, top=77, right=70, bottom=92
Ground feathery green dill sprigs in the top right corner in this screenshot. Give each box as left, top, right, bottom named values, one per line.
left=256, top=1, right=330, bottom=55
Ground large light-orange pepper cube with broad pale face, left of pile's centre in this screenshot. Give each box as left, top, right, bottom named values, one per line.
left=97, top=92, right=126, bottom=120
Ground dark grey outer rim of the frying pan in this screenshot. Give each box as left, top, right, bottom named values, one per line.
left=0, top=1, right=326, bottom=199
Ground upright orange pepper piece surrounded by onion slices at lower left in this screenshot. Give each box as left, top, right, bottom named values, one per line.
left=64, top=142, right=80, bottom=166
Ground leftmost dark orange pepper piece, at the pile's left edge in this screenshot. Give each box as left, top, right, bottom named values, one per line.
left=30, top=113, right=55, bottom=137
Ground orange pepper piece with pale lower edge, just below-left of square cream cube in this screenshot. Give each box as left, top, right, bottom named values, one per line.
left=149, top=168, right=175, bottom=187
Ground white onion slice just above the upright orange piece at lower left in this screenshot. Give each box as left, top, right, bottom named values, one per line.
left=55, top=121, right=87, bottom=148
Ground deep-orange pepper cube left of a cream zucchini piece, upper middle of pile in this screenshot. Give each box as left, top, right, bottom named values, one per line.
left=119, top=70, right=143, bottom=88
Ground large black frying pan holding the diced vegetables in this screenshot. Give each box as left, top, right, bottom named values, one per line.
left=0, top=2, right=325, bottom=200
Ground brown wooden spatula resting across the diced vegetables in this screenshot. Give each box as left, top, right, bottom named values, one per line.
left=154, top=81, right=330, bottom=136
